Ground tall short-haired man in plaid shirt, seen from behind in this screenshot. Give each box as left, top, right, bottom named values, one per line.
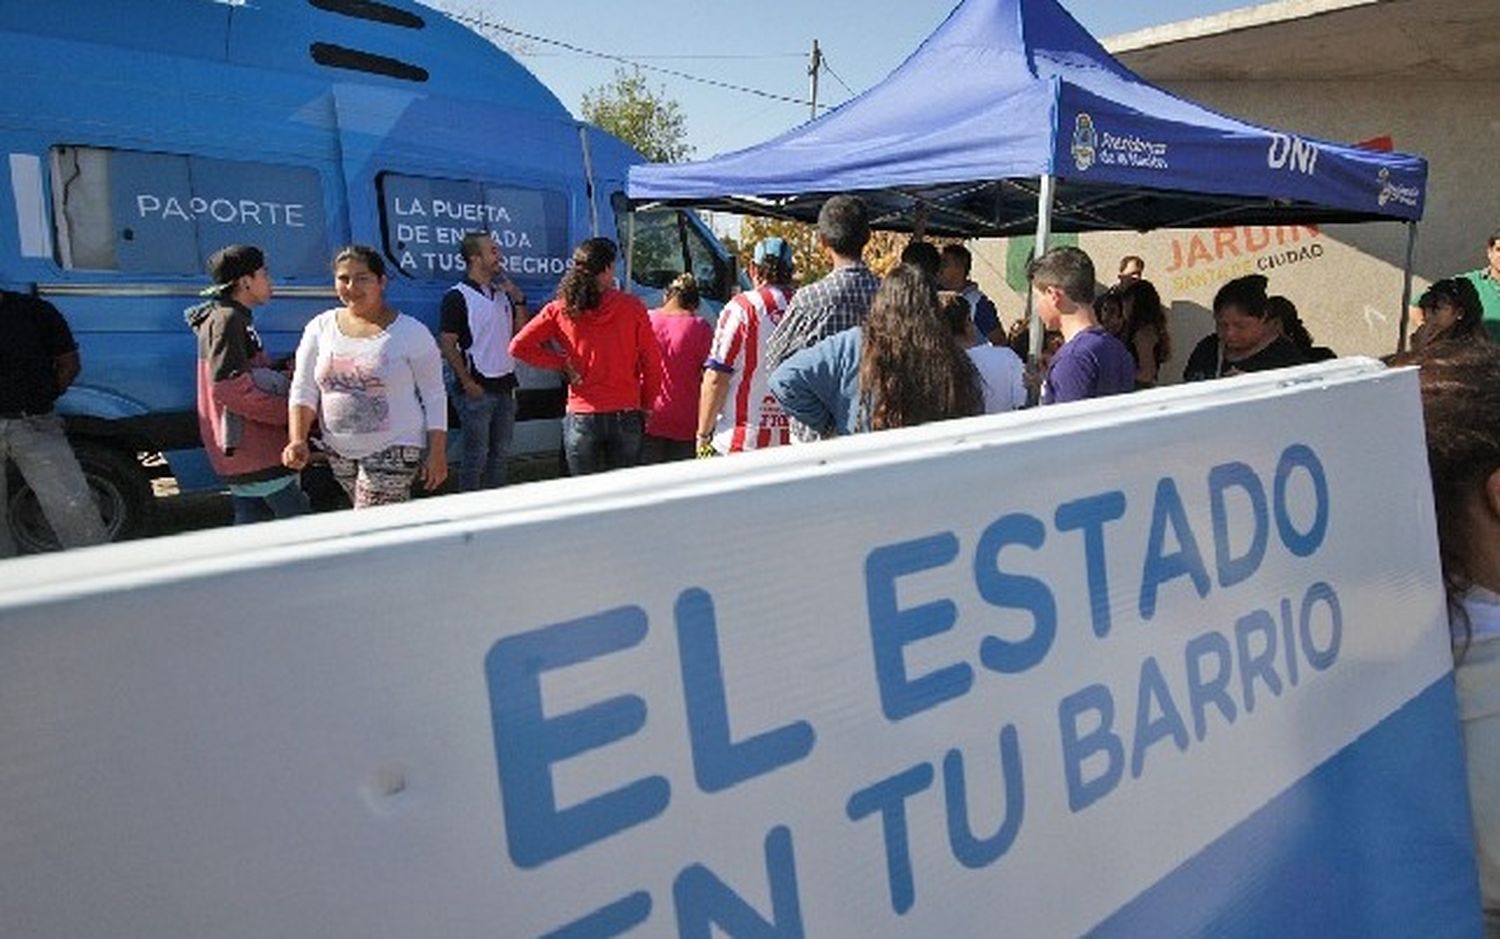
left=765, top=195, right=881, bottom=376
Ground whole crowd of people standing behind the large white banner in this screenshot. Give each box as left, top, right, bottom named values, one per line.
left=0, top=195, right=1500, bottom=930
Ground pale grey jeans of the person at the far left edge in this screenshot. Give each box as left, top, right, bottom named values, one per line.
left=0, top=414, right=105, bottom=558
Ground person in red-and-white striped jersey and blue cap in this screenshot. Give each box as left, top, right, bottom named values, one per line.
left=698, top=237, right=792, bottom=456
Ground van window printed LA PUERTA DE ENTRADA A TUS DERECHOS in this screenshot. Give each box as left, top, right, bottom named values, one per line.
left=377, top=173, right=573, bottom=281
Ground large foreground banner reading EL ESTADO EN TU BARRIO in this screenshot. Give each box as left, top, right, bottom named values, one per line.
left=0, top=362, right=1478, bottom=938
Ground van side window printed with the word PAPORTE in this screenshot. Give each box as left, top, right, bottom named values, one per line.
left=51, top=147, right=329, bottom=276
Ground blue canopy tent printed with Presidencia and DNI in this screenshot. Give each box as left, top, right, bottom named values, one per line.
left=629, top=0, right=1427, bottom=351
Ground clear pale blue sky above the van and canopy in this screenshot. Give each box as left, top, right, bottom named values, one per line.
left=426, top=0, right=1254, bottom=159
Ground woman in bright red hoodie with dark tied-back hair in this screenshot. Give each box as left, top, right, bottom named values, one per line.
left=510, top=239, right=662, bottom=476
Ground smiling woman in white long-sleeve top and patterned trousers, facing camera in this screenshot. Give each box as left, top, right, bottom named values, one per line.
left=282, top=245, right=449, bottom=509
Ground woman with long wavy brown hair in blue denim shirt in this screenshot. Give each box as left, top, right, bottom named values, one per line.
left=771, top=264, right=984, bottom=437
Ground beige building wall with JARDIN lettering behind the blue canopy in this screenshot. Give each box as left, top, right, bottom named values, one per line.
left=974, top=77, right=1500, bottom=381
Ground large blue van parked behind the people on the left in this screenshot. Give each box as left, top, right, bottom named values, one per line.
left=0, top=0, right=740, bottom=551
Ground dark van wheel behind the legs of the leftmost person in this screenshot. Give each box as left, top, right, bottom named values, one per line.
left=9, top=441, right=152, bottom=554
